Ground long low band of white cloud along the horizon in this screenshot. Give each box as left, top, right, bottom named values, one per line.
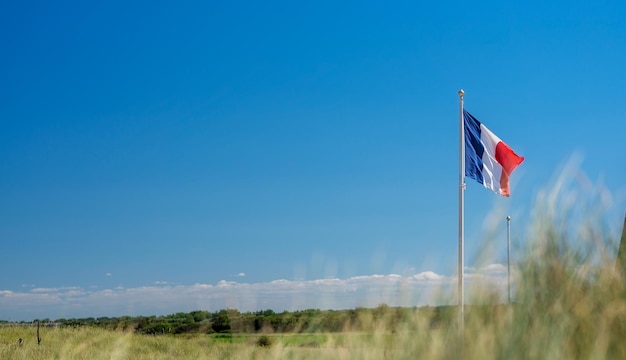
left=0, top=264, right=506, bottom=320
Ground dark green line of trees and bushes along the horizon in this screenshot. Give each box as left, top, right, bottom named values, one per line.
left=20, top=304, right=455, bottom=335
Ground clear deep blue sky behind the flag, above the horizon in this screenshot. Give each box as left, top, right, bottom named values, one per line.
left=0, top=1, right=626, bottom=320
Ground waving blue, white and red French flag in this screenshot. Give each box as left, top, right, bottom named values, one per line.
left=463, top=110, right=524, bottom=197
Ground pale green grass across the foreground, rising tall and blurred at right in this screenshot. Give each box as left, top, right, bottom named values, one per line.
left=0, top=174, right=626, bottom=360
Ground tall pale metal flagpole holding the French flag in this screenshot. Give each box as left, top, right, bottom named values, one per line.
left=458, top=89, right=465, bottom=336
